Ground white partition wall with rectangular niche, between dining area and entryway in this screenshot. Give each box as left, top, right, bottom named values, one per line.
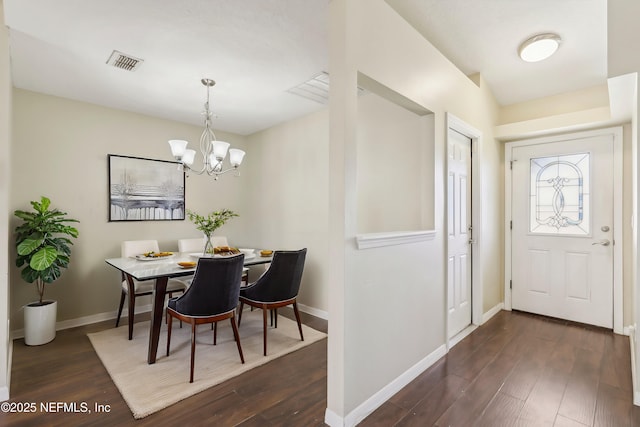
left=326, top=0, right=503, bottom=425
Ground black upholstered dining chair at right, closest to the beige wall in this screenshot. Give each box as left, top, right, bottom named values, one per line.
left=238, top=248, right=307, bottom=356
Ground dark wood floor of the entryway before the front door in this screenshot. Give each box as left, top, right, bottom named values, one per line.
left=361, top=311, right=640, bottom=427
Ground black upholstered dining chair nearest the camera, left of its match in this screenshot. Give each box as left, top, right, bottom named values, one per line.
left=167, top=254, right=244, bottom=383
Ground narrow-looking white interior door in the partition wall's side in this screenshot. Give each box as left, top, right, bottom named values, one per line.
left=447, top=129, right=472, bottom=338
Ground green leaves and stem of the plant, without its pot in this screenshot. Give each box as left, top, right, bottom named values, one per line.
left=14, top=196, right=79, bottom=305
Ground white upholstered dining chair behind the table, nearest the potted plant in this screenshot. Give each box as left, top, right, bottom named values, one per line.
left=116, top=240, right=187, bottom=340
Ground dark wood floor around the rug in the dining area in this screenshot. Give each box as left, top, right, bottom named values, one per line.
left=0, top=309, right=327, bottom=427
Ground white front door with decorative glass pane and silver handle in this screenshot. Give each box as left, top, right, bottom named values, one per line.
left=511, top=135, right=614, bottom=328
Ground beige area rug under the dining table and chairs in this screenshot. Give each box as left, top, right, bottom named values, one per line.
left=88, top=309, right=326, bottom=418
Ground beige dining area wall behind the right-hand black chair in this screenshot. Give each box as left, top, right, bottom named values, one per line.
left=242, top=109, right=330, bottom=317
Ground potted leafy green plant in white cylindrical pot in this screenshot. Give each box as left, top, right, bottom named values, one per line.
left=14, top=196, right=79, bottom=345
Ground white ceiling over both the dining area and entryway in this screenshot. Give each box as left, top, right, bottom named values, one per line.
left=4, top=0, right=607, bottom=135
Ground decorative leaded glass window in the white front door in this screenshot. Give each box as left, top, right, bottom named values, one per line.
left=529, top=153, right=590, bottom=236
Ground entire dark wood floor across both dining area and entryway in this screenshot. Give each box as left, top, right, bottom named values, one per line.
left=0, top=312, right=640, bottom=427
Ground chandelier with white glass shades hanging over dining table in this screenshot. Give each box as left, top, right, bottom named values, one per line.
left=169, top=79, right=245, bottom=180
